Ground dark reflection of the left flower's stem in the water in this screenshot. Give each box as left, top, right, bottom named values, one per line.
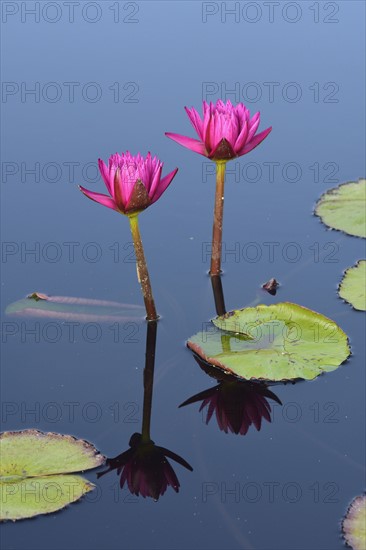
left=141, top=321, right=157, bottom=443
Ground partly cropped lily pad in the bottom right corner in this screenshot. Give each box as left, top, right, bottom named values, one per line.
left=342, top=495, right=366, bottom=550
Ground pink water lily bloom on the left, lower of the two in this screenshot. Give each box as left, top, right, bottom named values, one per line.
left=79, top=151, right=178, bottom=215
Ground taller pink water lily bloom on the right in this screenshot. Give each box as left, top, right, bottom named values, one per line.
left=165, top=99, right=272, bottom=161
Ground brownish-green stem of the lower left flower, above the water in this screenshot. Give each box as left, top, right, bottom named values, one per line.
left=128, top=214, right=158, bottom=321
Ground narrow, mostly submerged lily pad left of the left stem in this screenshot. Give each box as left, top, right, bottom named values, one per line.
left=5, top=292, right=145, bottom=322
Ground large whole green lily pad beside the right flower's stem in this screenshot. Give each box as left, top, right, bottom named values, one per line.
left=187, top=302, right=350, bottom=381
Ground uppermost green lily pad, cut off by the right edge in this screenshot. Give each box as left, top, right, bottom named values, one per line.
left=315, top=179, right=366, bottom=237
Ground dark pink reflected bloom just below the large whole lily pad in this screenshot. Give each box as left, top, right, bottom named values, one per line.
left=180, top=357, right=282, bottom=435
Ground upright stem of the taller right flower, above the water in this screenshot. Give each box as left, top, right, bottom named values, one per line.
left=210, top=160, right=227, bottom=276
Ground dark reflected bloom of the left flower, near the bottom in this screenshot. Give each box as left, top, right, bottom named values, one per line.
left=98, top=433, right=193, bottom=500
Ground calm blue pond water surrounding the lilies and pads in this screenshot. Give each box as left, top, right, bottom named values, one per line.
left=1, top=0, right=366, bottom=550
